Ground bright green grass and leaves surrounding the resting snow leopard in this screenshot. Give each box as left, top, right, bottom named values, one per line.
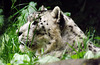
left=0, top=2, right=100, bottom=65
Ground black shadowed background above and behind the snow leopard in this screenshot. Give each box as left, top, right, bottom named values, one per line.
left=0, top=0, right=100, bottom=35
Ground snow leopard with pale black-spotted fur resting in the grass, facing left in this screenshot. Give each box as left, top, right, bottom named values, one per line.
left=16, top=6, right=100, bottom=57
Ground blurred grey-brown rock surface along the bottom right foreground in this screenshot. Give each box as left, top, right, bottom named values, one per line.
left=43, top=58, right=100, bottom=65
